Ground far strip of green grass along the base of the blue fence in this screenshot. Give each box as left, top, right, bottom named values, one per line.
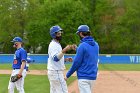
left=0, top=64, right=140, bottom=71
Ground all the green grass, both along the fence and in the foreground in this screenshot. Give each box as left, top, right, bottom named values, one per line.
left=0, top=64, right=140, bottom=93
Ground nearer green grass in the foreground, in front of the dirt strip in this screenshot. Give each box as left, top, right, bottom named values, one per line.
left=0, top=75, right=76, bottom=93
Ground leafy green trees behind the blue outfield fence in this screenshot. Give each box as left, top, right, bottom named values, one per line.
left=0, top=0, right=140, bottom=54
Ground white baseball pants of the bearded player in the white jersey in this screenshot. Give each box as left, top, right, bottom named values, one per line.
left=48, top=70, right=68, bottom=93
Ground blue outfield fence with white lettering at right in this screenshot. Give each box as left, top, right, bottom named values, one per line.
left=0, top=54, right=140, bottom=64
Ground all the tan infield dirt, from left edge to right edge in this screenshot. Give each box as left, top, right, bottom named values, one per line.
left=0, top=70, right=140, bottom=93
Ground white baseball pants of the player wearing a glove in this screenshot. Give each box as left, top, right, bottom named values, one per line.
left=8, top=69, right=26, bottom=93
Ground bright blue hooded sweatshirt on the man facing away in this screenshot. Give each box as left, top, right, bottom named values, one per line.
left=66, top=36, right=99, bottom=80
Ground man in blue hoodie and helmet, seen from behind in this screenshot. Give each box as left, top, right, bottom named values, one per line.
left=65, top=25, right=99, bottom=93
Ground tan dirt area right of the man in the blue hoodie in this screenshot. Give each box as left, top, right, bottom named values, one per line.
left=94, top=71, right=140, bottom=93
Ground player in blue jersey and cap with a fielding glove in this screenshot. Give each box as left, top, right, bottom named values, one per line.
left=8, top=37, right=27, bottom=93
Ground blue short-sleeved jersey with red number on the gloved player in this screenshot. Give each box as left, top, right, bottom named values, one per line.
left=13, top=47, right=27, bottom=69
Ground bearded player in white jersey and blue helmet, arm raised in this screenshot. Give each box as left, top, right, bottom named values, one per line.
left=47, top=26, right=75, bottom=93
